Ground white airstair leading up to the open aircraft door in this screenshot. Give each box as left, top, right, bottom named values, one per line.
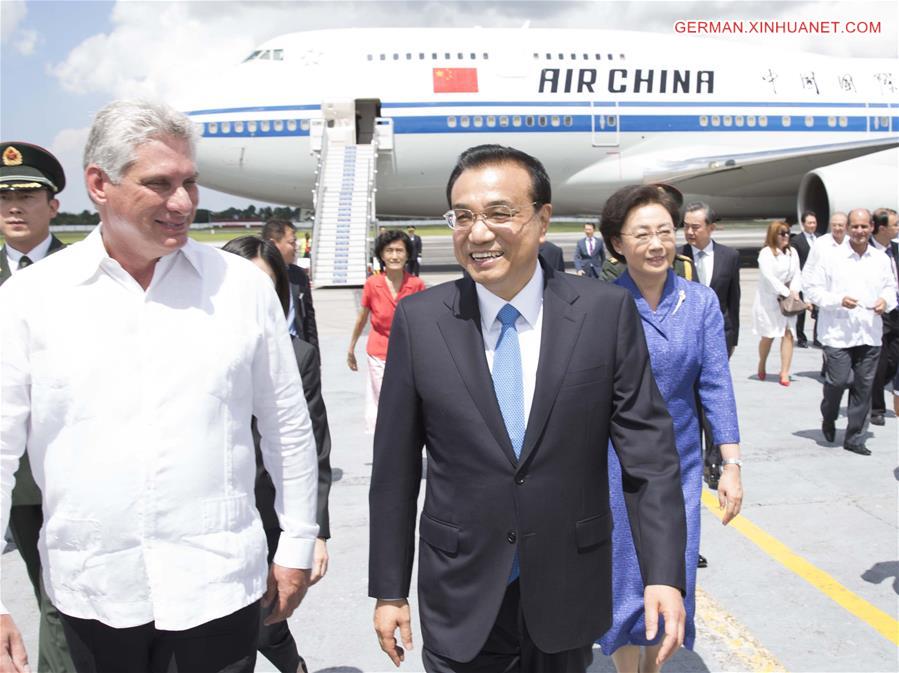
left=312, top=134, right=378, bottom=287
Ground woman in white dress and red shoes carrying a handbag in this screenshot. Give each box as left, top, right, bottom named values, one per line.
left=752, top=221, right=802, bottom=386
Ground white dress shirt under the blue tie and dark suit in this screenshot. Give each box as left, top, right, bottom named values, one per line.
left=475, top=264, right=543, bottom=427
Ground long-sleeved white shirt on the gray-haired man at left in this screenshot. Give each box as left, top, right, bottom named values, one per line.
left=0, top=225, right=318, bottom=631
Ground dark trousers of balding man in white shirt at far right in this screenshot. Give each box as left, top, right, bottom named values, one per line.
left=821, top=346, right=880, bottom=447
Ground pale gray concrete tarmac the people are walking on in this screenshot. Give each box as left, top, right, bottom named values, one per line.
left=0, top=260, right=899, bottom=673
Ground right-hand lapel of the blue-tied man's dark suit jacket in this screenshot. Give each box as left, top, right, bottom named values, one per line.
left=519, top=267, right=584, bottom=464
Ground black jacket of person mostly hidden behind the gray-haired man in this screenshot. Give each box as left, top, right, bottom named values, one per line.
left=253, top=339, right=331, bottom=540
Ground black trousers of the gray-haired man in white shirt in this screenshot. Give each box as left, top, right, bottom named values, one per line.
left=62, top=601, right=259, bottom=673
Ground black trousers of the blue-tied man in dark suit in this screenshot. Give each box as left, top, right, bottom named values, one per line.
left=421, top=580, right=593, bottom=673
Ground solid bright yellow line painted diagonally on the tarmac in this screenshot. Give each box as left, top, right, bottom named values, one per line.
left=702, top=489, right=899, bottom=645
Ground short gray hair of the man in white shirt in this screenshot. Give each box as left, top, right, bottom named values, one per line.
left=83, top=100, right=197, bottom=183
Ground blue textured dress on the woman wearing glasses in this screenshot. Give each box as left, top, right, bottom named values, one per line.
left=597, top=271, right=740, bottom=654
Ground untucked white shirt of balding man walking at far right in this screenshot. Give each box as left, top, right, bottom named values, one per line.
left=803, top=245, right=896, bottom=348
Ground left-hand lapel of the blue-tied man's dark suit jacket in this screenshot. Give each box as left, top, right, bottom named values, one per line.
left=437, top=277, right=520, bottom=465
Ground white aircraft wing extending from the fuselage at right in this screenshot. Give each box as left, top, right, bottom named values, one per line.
left=644, top=136, right=899, bottom=196
